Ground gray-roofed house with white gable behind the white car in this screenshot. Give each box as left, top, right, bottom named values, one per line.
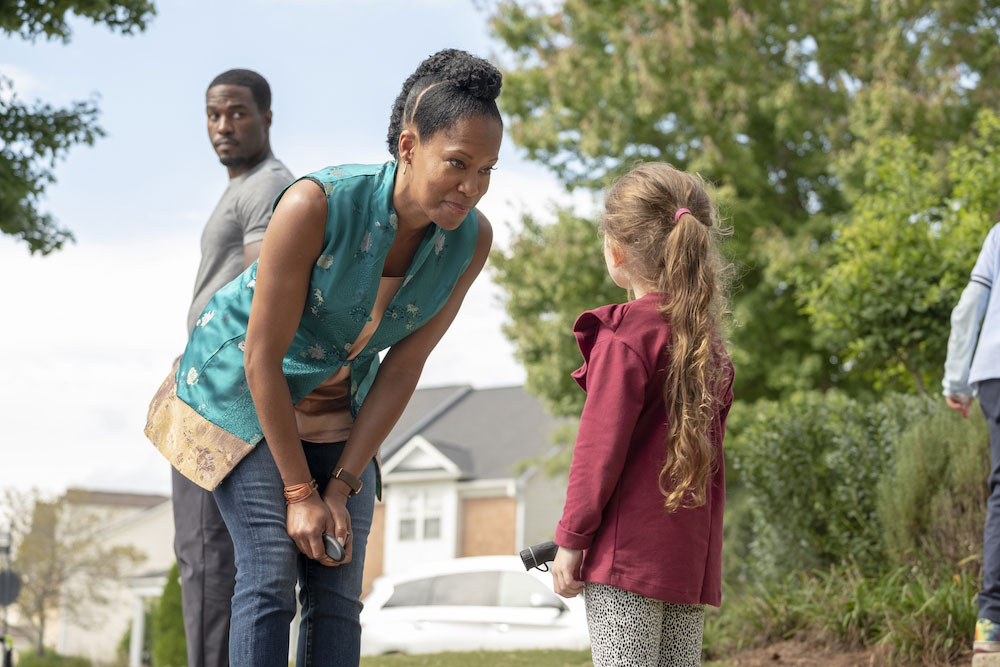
left=364, top=385, right=568, bottom=592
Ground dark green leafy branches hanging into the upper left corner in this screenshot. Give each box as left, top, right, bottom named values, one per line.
left=0, top=0, right=155, bottom=255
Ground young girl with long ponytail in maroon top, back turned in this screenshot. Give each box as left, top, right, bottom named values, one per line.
left=552, top=163, right=733, bottom=667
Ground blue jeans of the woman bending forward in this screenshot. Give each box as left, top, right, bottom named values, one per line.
left=215, top=441, right=375, bottom=667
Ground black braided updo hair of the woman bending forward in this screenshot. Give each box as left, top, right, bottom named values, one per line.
left=386, top=49, right=503, bottom=159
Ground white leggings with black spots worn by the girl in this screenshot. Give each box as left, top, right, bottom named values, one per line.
left=583, top=583, right=705, bottom=667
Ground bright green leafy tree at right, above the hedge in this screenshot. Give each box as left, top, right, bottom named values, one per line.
left=803, top=111, right=1000, bottom=392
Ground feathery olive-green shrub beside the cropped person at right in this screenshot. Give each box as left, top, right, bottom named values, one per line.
left=878, top=401, right=990, bottom=573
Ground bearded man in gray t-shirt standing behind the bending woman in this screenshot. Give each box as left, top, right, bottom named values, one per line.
left=173, top=69, right=292, bottom=667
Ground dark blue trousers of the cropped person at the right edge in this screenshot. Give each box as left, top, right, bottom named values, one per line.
left=978, top=380, right=1000, bottom=623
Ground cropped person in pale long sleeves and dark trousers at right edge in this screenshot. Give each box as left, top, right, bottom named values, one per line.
left=941, top=225, right=1000, bottom=653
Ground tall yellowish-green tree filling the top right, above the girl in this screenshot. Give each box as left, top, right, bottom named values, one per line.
left=491, top=0, right=1000, bottom=398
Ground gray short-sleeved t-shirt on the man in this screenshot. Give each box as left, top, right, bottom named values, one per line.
left=187, top=155, right=293, bottom=333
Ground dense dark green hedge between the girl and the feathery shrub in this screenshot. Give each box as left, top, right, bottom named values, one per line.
left=731, top=392, right=935, bottom=580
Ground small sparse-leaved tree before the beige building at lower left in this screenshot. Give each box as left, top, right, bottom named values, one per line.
left=0, top=490, right=145, bottom=656
